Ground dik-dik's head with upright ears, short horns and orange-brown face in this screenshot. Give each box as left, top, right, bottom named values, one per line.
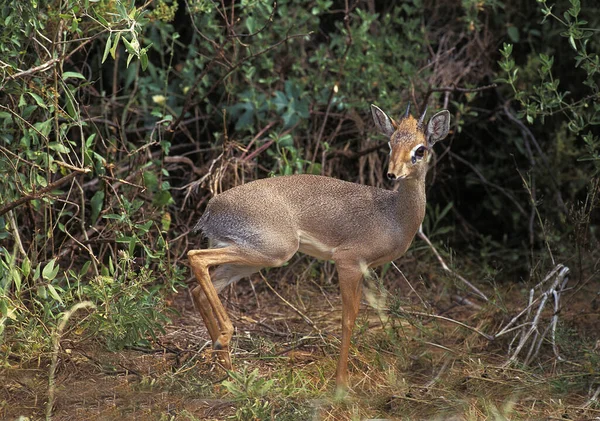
left=371, top=104, right=450, bottom=180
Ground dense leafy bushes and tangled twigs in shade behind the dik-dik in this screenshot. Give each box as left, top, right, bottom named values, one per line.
left=0, top=0, right=600, bottom=416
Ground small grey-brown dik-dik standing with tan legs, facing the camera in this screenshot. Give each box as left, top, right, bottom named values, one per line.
left=188, top=105, right=450, bottom=389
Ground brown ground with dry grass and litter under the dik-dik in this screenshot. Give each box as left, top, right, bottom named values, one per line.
left=0, top=258, right=600, bottom=421
